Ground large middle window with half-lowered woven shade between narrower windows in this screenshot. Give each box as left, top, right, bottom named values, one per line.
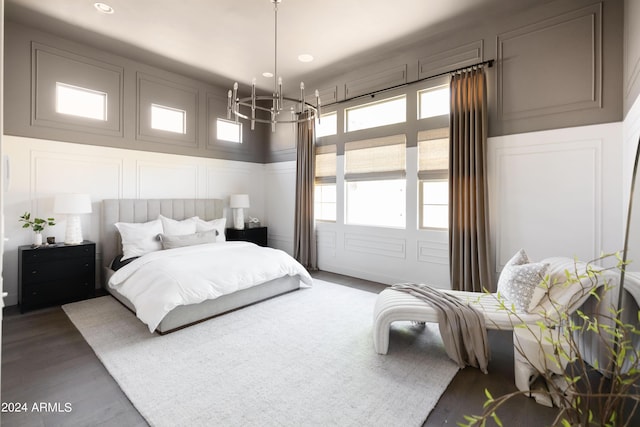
left=344, top=135, right=406, bottom=227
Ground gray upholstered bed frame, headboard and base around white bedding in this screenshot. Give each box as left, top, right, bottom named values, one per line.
left=101, top=199, right=311, bottom=334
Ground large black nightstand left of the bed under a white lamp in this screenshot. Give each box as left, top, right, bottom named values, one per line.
left=18, top=240, right=96, bottom=313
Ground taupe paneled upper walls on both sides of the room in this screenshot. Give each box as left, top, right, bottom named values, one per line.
left=5, top=0, right=628, bottom=163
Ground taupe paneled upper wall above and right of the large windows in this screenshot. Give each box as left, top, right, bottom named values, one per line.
left=271, top=0, right=624, bottom=163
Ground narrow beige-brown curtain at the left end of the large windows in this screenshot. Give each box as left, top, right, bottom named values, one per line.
left=293, top=114, right=318, bottom=270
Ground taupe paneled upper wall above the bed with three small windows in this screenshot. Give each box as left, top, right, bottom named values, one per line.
left=4, top=22, right=269, bottom=163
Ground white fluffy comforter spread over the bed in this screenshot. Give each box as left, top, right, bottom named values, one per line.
left=109, top=242, right=312, bottom=332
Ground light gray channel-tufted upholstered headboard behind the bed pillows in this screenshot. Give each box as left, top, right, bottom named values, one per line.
left=100, top=199, right=224, bottom=284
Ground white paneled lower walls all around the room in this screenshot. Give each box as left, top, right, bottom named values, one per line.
left=3, top=122, right=624, bottom=304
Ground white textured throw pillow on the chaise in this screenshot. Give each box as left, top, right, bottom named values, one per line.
left=498, top=249, right=549, bottom=313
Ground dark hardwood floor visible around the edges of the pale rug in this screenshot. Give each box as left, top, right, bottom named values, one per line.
left=0, top=272, right=556, bottom=427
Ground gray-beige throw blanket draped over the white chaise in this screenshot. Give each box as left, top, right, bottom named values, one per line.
left=391, top=283, right=489, bottom=374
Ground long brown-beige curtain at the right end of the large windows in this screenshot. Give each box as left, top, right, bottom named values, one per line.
left=449, top=68, right=493, bottom=292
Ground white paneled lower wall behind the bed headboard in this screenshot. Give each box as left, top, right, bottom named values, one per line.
left=3, top=136, right=264, bottom=305
